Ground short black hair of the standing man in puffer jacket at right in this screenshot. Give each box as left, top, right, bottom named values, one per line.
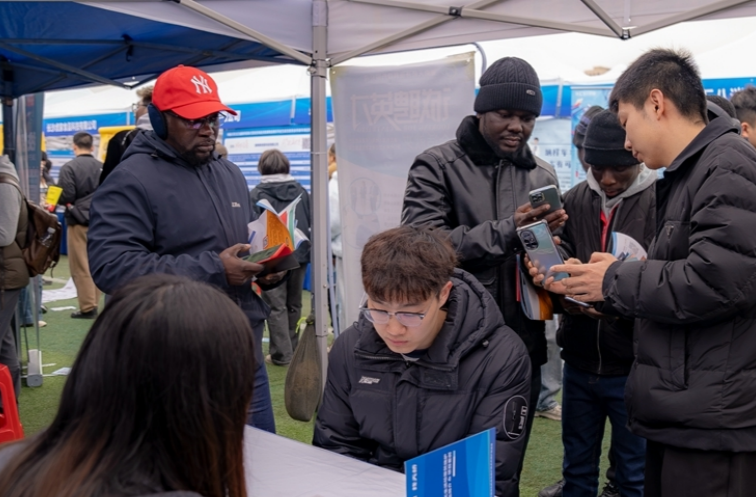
left=609, top=48, right=708, bottom=122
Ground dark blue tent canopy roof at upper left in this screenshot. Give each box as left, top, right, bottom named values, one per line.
left=0, top=2, right=292, bottom=97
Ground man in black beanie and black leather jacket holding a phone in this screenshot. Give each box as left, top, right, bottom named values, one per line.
left=402, top=57, right=567, bottom=488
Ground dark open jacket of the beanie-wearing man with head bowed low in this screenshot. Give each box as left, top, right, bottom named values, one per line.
left=557, top=166, right=656, bottom=376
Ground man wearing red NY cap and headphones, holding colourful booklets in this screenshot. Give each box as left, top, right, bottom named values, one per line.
left=88, top=66, right=281, bottom=432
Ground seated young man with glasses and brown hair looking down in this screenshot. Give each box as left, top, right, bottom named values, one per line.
left=313, top=226, right=531, bottom=497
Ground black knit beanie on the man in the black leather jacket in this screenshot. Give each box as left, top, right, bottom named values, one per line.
left=475, top=57, right=543, bottom=116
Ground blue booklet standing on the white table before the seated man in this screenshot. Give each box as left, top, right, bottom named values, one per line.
left=404, top=428, right=496, bottom=497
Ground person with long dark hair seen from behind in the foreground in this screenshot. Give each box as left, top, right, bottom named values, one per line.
left=0, top=275, right=255, bottom=497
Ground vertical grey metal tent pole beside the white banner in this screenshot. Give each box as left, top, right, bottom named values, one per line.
left=310, top=0, right=331, bottom=389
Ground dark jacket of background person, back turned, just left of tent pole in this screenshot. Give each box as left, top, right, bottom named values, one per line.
left=249, top=174, right=312, bottom=267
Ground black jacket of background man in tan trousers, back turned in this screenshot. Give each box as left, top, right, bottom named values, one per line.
left=58, top=154, right=102, bottom=225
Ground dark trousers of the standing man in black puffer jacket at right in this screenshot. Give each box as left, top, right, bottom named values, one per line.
left=644, top=440, right=756, bottom=497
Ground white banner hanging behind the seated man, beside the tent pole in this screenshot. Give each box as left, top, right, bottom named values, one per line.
left=331, top=53, right=475, bottom=328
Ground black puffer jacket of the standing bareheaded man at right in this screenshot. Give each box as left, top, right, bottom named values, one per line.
left=603, top=119, right=756, bottom=452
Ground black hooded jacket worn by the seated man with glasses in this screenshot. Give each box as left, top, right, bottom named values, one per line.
left=313, top=270, right=531, bottom=496
